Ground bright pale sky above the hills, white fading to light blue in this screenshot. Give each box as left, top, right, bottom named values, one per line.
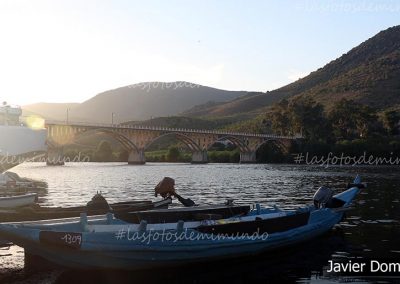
left=0, top=0, right=400, bottom=105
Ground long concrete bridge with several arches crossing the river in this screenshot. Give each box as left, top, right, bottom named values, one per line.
left=45, top=122, right=300, bottom=165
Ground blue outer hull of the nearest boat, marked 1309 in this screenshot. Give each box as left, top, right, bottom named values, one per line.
left=2, top=206, right=343, bottom=270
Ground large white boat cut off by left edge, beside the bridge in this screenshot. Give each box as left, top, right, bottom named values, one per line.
left=0, top=103, right=47, bottom=172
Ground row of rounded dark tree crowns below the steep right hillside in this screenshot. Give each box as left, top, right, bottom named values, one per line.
left=266, top=98, right=399, bottom=142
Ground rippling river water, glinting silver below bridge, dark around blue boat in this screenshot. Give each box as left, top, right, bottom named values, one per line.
left=0, top=163, right=400, bottom=283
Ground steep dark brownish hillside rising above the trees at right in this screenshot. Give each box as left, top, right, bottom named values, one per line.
left=185, top=26, right=400, bottom=116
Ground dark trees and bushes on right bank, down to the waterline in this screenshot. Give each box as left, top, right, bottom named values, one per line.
left=258, top=97, right=400, bottom=162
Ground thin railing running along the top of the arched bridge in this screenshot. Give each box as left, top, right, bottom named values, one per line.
left=45, top=120, right=302, bottom=139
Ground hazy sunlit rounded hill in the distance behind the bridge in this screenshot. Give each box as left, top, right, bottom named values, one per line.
left=23, top=82, right=248, bottom=123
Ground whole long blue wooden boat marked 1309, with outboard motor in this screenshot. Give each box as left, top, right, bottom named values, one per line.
left=0, top=177, right=363, bottom=270
